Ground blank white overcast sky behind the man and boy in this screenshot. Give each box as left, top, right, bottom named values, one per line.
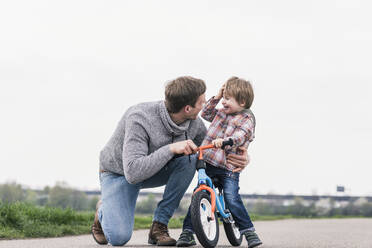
left=0, top=0, right=372, bottom=195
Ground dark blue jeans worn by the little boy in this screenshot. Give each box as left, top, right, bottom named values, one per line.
left=183, top=164, right=255, bottom=233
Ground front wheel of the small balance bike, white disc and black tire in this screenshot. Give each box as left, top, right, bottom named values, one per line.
left=190, top=191, right=219, bottom=248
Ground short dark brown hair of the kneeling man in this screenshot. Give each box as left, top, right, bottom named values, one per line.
left=165, top=76, right=206, bottom=113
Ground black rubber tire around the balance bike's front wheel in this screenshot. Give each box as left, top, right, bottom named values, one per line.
left=190, top=191, right=219, bottom=248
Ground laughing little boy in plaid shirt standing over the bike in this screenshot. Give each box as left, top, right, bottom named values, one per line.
left=177, top=77, right=262, bottom=248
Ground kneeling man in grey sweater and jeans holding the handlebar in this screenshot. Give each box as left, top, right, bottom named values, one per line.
left=92, top=77, right=247, bottom=246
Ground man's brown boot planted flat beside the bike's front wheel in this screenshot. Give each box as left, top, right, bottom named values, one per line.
left=148, top=221, right=176, bottom=246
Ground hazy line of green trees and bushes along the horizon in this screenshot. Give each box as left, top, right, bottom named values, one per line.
left=0, top=182, right=372, bottom=217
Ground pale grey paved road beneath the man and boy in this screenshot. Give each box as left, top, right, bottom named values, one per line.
left=0, top=219, right=372, bottom=248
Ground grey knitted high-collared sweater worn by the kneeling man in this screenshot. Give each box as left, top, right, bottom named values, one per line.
left=100, top=101, right=207, bottom=184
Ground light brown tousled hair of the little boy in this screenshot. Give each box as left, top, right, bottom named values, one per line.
left=224, top=77, right=254, bottom=109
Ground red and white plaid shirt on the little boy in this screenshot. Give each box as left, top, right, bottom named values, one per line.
left=201, top=97, right=255, bottom=171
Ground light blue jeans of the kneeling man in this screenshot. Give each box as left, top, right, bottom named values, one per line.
left=98, top=155, right=196, bottom=245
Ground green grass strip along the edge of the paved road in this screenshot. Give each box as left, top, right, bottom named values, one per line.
left=0, top=202, right=364, bottom=239
